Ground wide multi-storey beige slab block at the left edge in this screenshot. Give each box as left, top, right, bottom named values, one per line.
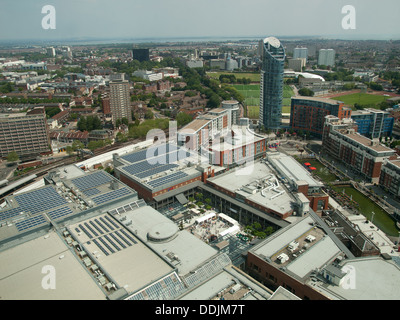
left=0, top=108, right=51, bottom=157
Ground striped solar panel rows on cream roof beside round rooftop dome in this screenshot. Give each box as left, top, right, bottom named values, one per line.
left=76, top=215, right=137, bottom=256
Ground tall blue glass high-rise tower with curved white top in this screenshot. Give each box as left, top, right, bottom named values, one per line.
left=259, top=37, right=285, bottom=129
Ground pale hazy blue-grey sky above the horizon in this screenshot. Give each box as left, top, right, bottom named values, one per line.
left=0, top=0, right=400, bottom=41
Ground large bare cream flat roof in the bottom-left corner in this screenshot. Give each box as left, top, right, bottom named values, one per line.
left=0, top=232, right=106, bottom=300
